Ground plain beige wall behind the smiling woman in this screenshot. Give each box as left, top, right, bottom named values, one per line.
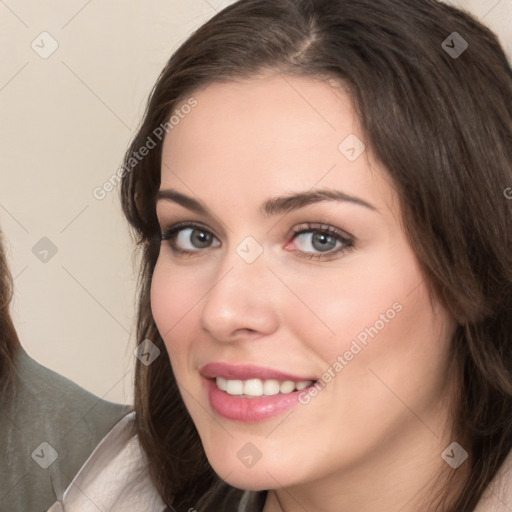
left=0, top=0, right=512, bottom=402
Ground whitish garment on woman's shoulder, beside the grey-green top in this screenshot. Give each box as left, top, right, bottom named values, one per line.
left=48, top=412, right=165, bottom=512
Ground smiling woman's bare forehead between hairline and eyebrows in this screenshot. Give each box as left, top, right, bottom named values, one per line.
left=162, top=75, right=396, bottom=212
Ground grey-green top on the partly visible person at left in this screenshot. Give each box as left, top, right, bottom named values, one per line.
left=0, top=350, right=130, bottom=512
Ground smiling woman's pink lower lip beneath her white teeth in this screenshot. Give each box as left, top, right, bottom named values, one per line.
left=205, top=379, right=313, bottom=423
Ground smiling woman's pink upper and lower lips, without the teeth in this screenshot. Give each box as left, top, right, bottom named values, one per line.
left=200, top=363, right=317, bottom=423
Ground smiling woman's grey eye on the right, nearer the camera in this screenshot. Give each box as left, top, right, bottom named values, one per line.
left=287, top=224, right=354, bottom=259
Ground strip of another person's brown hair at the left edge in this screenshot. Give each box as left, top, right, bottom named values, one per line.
left=0, top=232, right=20, bottom=399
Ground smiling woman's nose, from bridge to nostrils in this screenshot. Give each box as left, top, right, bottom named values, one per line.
left=201, top=245, right=279, bottom=342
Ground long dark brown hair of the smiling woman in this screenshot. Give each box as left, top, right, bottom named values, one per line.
left=122, top=0, right=512, bottom=512
